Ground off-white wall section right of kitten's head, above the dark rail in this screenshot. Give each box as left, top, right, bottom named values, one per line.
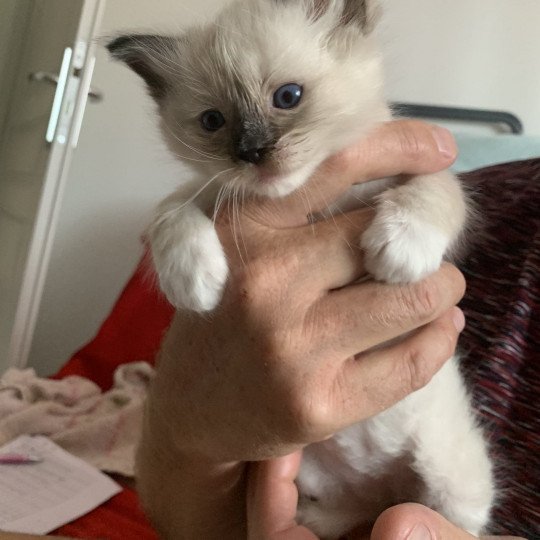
left=380, top=0, right=540, bottom=135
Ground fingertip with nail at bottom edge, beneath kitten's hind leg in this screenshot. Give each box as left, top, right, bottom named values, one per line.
left=371, top=504, right=517, bottom=540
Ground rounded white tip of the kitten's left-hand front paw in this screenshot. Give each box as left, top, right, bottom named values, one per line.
left=153, top=220, right=229, bottom=312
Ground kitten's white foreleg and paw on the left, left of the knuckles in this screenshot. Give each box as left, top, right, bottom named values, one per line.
left=149, top=204, right=229, bottom=312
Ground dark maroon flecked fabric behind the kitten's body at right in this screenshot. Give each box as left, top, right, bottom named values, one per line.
left=460, top=160, right=540, bottom=540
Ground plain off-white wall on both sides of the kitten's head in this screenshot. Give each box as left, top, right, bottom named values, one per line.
left=30, top=0, right=540, bottom=374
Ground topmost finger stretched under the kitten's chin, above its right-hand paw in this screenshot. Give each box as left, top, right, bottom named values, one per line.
left=245, top=120, right=457, bottom=228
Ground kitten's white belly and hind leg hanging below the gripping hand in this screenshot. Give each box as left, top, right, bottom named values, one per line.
left=297, top=358, right=494, bottom=539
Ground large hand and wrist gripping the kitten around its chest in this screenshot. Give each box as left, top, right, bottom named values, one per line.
left=139, top=121, right=516, bottom=540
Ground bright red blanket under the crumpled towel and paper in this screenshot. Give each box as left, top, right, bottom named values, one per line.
left=55, top=260, right=173, bottom=540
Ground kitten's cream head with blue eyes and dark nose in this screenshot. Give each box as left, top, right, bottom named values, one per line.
left=107, top=0, right=386, bottom=196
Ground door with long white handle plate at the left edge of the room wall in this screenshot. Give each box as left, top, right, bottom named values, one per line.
left=0, top=0, right=105, bottom=374
